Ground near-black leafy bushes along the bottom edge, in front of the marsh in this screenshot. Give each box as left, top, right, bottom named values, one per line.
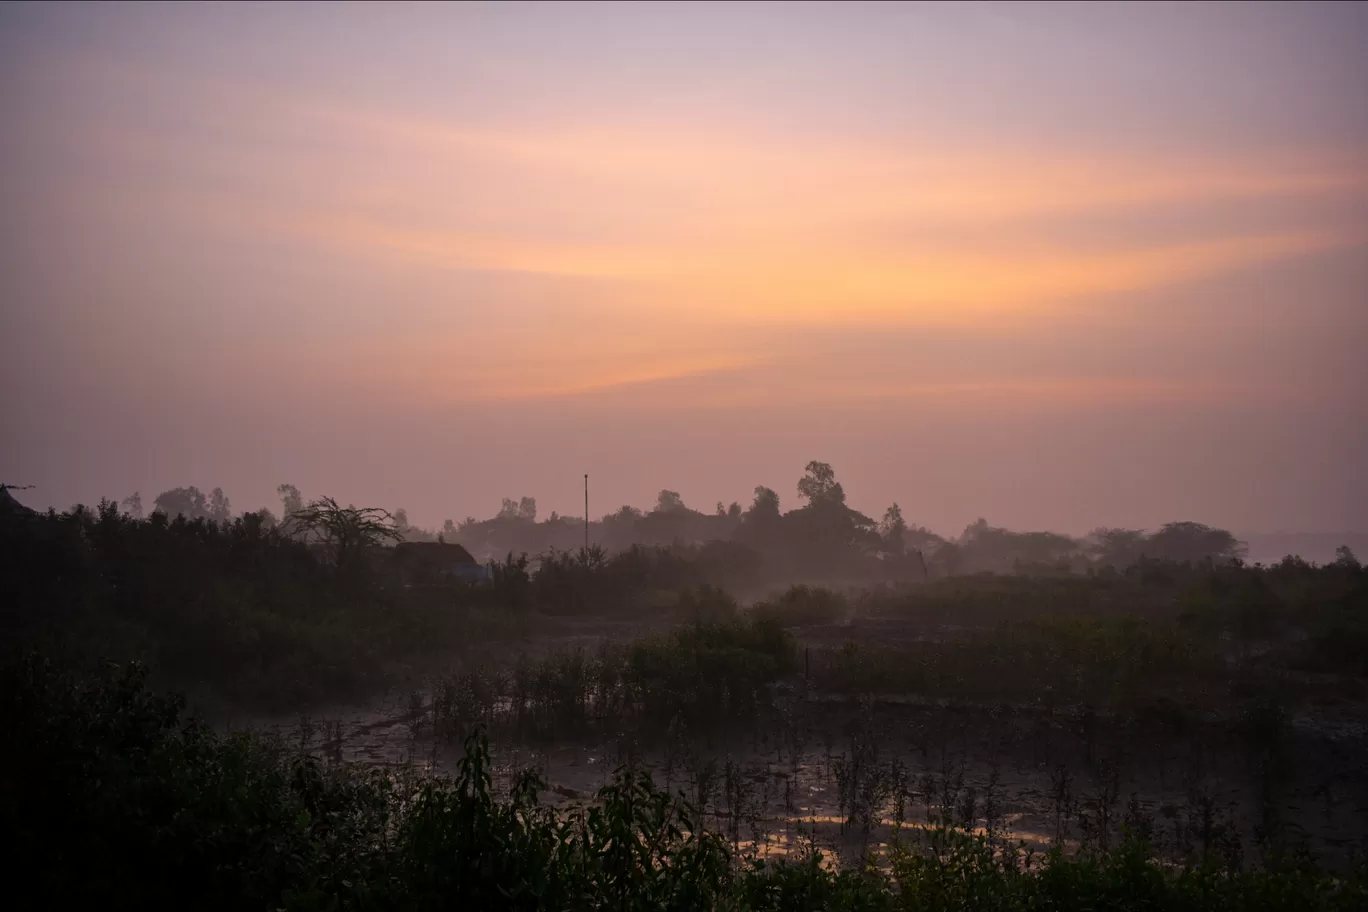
left=8, top=659, right=1368, bottom=911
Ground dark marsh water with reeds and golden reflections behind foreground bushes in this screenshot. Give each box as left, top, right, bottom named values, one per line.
left=233, top=636, right=1368, bottom=864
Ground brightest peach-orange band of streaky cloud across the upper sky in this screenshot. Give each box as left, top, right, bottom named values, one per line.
left=240, top=111, right=1368, bottom=323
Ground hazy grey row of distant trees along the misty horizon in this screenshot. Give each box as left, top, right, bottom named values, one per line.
left=120, top=461, right=1269, bottom=581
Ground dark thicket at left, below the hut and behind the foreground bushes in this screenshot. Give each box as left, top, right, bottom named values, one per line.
left=0, top=502, right=513, bottom=707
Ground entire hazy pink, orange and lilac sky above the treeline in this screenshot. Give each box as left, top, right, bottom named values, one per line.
left=0, top=3, right=1368, bottom=533
